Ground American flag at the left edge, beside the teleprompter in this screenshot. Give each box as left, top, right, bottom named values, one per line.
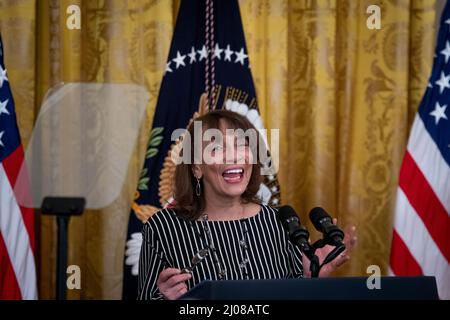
left=0, top=33, right=37, bottom=300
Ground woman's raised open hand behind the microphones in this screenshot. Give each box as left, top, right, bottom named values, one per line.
left=303, top=218, right=358, bottom=278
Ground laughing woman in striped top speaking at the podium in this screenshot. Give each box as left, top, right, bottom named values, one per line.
left=138, top=110, right=356, bottom=299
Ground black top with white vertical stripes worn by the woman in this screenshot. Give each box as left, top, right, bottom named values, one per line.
left=138, top=205, right=303, bottom=299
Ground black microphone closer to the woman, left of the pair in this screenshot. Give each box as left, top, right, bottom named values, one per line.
left=278, top=206, right=315, bottom=260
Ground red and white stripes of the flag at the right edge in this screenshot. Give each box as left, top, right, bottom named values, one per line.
left=390, top=115, right=450, bottom=299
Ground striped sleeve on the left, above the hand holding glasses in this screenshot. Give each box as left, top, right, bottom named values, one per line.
left=138, top=222, right=164, bottom=300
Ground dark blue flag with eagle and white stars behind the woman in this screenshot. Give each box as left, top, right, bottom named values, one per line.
left=123, top=0, right=280, bottom=299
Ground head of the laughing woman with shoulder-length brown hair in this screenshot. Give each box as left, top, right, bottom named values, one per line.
left=175, top=110, right=266, bottom=220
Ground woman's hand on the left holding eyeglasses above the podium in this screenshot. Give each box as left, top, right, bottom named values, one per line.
left=156, top=268, right=192, bottom=300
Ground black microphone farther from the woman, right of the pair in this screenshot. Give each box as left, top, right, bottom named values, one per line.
left=309, top=207, right=344, bottom=247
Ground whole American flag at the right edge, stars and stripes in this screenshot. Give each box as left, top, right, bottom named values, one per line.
left=390, top=2, right=450, bottom=299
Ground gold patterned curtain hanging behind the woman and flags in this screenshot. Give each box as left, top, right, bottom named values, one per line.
left=0, top=0, right=440, bottom=299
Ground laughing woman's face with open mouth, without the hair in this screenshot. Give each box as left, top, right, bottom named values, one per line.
left=194, top=123, right=253, bottom=198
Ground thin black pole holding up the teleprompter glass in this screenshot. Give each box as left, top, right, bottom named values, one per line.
left=56, top=215, right=70, bottom=300
